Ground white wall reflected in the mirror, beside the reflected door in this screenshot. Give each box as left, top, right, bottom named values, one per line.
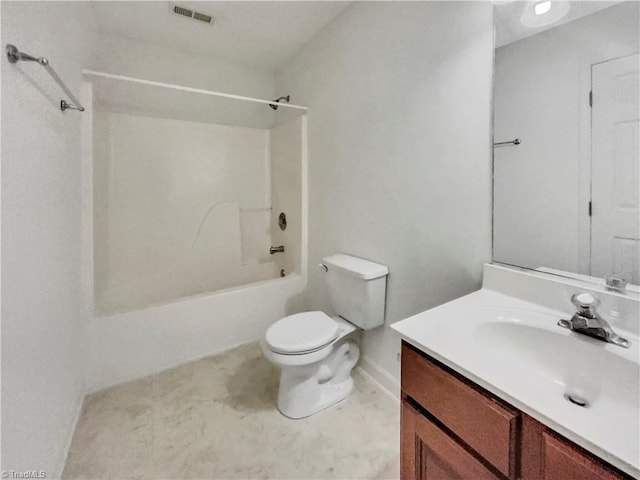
left=494, top=1, right=640, bottom=274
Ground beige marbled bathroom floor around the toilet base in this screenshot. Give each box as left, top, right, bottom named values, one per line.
left=63, top=344, right=400, bottom=479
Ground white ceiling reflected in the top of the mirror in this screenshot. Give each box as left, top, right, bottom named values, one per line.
left=495, top=0, right=621, bottom=47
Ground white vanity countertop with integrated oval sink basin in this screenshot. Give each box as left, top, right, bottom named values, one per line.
left=391, top=289, right=640, bottom=478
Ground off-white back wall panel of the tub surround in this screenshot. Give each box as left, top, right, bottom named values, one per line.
left=93, top=112, right=275, bottom=316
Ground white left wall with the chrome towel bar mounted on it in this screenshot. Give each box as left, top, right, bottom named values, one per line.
left=1, top=2, right=96, bottom=478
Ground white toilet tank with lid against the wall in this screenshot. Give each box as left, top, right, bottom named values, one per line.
left=322, top=254, right=389, bottom=330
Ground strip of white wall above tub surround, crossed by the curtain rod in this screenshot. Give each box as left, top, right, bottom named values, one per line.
left=88, top=37, right=283, bottom=128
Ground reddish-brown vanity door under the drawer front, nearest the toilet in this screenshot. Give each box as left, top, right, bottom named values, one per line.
left=400, top=401, right=499, bottom=480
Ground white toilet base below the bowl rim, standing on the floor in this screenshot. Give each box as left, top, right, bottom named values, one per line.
left=278, top=342, right=360, bottom=419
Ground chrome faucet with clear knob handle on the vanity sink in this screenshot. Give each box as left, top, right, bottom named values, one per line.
left=558, top=293, right=630, bottom=348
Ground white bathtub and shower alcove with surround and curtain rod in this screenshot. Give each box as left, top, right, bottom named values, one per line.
left=82, top=71, right=307, bottom=390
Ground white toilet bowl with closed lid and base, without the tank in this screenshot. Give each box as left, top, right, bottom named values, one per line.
left=261, top=312, right=360, bottom=418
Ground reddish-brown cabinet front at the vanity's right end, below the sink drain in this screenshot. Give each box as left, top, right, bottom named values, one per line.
left=522, top=416, right=630, bottom=480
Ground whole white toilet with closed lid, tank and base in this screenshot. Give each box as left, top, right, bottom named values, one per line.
left=261, top=254, right=389, bottom=418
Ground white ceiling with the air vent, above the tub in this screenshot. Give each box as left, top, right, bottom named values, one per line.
left=91, top=0, right=350, bottom=70
